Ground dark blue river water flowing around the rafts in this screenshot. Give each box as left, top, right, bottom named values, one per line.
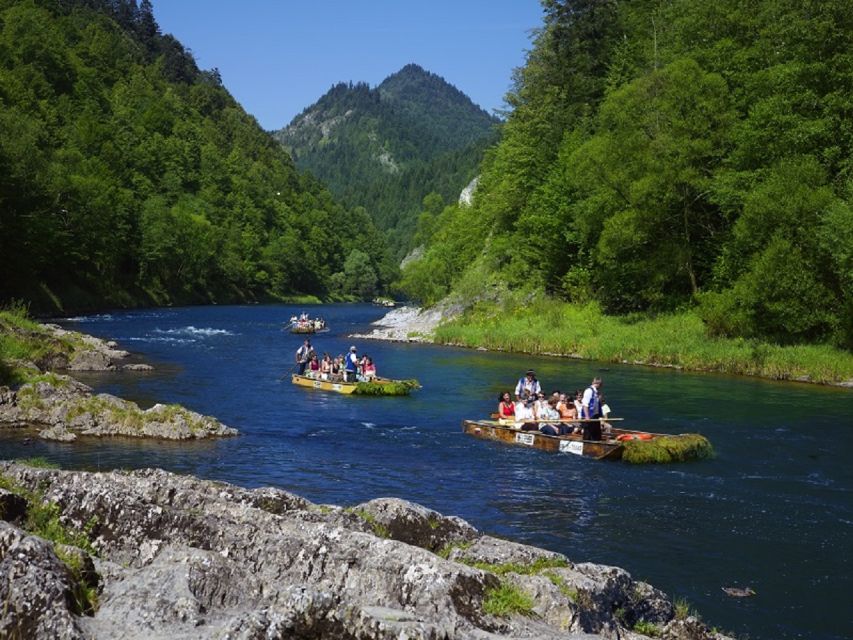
left=0, top=305, right=853, bottom=640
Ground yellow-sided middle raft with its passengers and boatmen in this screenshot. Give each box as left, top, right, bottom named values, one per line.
left=290, top=339, right=421, bottom=396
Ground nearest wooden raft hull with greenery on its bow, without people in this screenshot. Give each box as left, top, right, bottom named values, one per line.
left=462, top=420, right=714, bottom=464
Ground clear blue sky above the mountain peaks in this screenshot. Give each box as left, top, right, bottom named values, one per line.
left=153, top=0, right=542, bottom=129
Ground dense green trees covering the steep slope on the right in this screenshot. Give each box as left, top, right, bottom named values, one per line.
left=402, top=0, right=853, bottom=349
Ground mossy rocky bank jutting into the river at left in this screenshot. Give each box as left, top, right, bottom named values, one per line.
left=0, top=308, right=238, bottom=442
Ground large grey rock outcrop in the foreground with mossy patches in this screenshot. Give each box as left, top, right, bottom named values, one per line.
left=0, top=463, right=722, bottom=640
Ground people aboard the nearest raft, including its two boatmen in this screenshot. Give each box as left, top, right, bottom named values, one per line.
left=497, top=369, right=610, bottom=440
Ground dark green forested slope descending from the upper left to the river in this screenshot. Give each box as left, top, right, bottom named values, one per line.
left=0, top=0, right=393, bottom=308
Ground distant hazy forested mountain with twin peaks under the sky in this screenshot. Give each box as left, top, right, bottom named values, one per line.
left=274, top=64, right=497, bottom=256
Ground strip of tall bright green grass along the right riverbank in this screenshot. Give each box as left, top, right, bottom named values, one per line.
left=435, top=299, right=853, bottom=384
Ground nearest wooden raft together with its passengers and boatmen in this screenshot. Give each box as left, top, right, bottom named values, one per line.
left=462, top=369, right=713, bottom=463
